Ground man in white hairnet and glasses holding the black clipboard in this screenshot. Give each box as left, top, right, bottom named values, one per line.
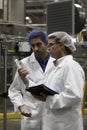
left=34, top=32, right=85, bottom=130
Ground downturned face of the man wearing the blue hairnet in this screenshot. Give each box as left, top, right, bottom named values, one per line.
left=31, top=38, right=47, bottom=58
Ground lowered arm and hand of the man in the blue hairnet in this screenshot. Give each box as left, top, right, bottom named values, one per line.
left=8, top=72, right=31, bottom=117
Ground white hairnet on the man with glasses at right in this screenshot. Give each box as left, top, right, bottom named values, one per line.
left=48, top=31, right=76, bottom=52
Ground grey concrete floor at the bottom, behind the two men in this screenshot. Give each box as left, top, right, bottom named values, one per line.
left=0, top=115, right=87, bottom=130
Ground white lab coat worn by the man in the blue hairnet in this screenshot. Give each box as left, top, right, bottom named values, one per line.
left=8, top=53, right=54, bottom=130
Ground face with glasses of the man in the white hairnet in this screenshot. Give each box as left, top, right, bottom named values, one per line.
left=48, top=38, right=63, bottom=59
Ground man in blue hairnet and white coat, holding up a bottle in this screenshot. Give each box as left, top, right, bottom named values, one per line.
left=8, top=30, right=54, bottom=130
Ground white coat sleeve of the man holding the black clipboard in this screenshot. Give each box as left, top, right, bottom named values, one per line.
left=46, top=67, right=85, bottom=109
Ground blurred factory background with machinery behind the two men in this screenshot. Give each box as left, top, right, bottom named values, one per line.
left=0, top=0, right=87, bottom=130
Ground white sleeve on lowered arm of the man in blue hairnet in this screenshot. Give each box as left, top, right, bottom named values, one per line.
left=8, top=73, right=24, bottom=112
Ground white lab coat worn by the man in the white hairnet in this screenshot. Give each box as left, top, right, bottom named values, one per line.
left=43, top=55, right=85, bottom=130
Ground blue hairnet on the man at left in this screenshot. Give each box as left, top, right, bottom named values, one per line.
left=28, top=30, right=48, bottom=45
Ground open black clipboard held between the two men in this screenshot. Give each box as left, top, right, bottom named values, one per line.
left=26, top=84, right=58, bottom=96
